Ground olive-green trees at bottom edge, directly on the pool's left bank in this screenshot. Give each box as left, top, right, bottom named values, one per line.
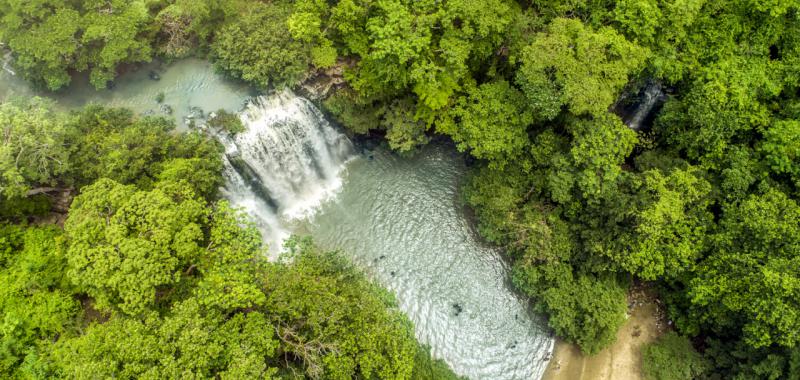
left=265, top=240, right=417, bottom=379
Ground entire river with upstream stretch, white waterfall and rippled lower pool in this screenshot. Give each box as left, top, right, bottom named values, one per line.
left=0, top=59, right=553, bottom=380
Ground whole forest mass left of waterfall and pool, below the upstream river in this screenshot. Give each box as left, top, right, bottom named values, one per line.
left=0, top=103, right=455, bottom=379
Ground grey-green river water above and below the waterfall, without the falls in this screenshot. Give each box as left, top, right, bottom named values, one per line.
left=0, top=59, right=553, bottom=380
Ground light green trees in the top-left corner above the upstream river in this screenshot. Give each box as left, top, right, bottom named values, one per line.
left=0, top=0, right=152, bottom=90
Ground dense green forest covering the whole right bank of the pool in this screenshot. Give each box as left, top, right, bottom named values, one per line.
left=282, top=0, right=800, bottom=378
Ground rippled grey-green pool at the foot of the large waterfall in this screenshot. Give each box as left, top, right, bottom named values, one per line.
left=308, top=145, right=552, bottom=380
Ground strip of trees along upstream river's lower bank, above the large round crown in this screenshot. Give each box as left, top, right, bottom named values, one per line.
left=0, top=98, right=222, bottom=200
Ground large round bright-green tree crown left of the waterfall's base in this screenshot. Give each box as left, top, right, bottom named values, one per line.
left=65, top=180, right=206, bottom=315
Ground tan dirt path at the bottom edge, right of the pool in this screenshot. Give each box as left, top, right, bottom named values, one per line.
left=543, top=291, right=665, bottom=380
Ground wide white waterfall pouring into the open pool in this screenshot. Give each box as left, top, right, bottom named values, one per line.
left=220, top=90, right=353, bottom=253
